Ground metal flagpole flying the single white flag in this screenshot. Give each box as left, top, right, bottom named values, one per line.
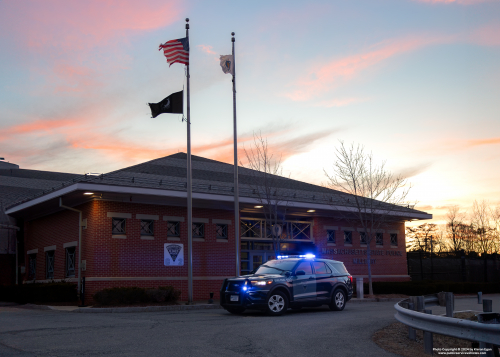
left=231, top=32, right=240, bottom=276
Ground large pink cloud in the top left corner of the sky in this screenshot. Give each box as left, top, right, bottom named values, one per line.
left=1, top=0, right=181, bottom=51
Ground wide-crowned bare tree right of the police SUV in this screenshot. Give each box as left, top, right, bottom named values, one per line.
left=325, top=141, right=411, bottom=295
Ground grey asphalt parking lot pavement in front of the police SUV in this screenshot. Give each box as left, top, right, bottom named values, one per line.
left=0, top=296, right=500, bottom=356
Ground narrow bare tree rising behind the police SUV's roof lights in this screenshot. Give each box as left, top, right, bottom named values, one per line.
left=240, top=133, right=289, bottom=256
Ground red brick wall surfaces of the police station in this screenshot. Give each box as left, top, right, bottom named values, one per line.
left=24, top=197, right=408, bottom=303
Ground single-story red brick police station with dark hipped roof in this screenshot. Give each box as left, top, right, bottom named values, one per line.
left=6, top=153, right=432, bottom=301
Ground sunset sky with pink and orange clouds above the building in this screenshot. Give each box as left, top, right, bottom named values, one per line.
left=0, top=0, right=500, bottom=222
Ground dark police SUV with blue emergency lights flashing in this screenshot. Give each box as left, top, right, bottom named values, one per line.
left=220, top=254, right=353, bottom=315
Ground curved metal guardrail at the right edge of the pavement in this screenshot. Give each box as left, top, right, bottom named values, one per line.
left=394, top=294, right=500, bottom=345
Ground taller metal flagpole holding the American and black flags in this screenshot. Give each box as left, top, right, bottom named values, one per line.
left=186, top=18, right=193, bottom=304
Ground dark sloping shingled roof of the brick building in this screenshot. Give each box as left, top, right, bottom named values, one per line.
left=0, top=153, right=432, bottom=219
